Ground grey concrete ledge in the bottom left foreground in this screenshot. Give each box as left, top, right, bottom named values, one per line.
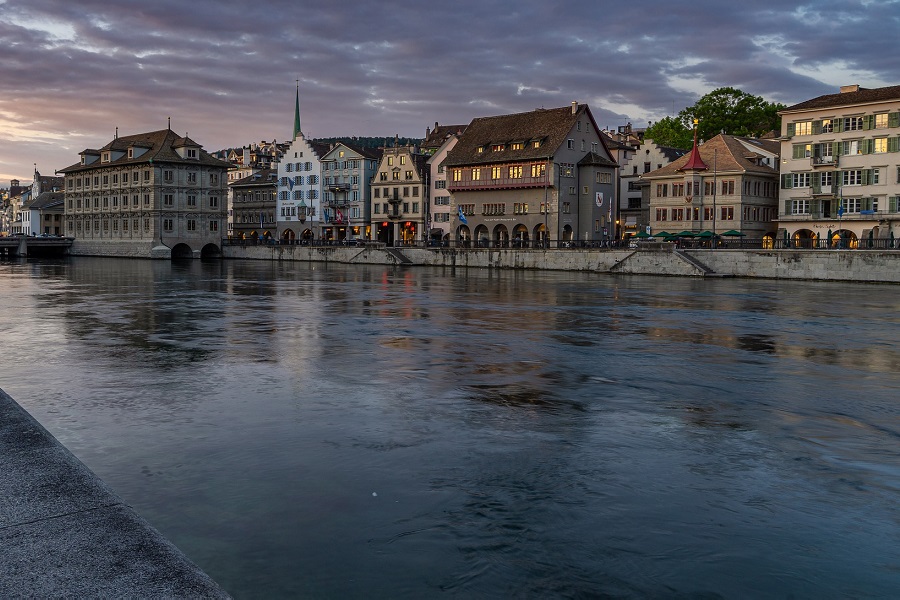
left=0, top=390, right=228, bottom=598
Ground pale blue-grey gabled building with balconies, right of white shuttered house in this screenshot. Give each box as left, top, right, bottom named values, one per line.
left=322, top=142, right=379, bottom=242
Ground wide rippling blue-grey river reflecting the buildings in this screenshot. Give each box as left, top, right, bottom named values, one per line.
left=0, top=258, right=900, bottom=598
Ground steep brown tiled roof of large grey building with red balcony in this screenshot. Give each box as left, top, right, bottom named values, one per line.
left=444, top=104, right=607, bottom=166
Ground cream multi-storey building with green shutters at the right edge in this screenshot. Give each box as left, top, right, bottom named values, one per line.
left=778, top=85, right=900, bottom=248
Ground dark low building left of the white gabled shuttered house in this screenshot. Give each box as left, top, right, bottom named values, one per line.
left=228, top=169, right=278, bottom=240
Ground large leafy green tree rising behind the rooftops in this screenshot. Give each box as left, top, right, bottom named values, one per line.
left=678, top=87, right=784, bottom=140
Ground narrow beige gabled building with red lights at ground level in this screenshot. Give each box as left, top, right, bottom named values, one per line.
left=372, top=145, right=430, bottom=246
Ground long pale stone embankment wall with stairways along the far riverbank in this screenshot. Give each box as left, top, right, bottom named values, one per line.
left=223, top=244, right=900, bottom=283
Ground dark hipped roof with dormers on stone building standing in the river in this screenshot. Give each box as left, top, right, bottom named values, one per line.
left=59, top=129, right=231, bottom=173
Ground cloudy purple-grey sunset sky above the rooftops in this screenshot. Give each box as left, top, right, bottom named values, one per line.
left=0, top=0, right=900, bottom=183
